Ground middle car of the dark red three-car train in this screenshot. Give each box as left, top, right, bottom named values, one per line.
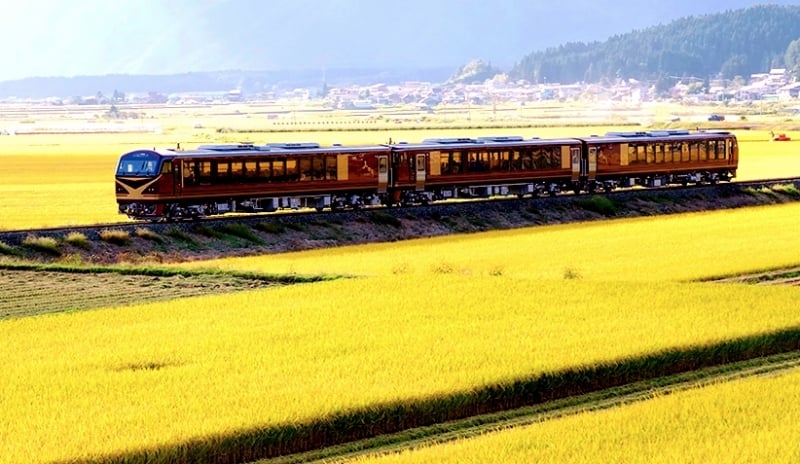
left=391, top=136, right=582, bottom=203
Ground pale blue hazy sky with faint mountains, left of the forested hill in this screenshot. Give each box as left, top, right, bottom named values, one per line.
left=0, top=0, right=800, bottom=81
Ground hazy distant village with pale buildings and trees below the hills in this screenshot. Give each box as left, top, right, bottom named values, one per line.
left=4, top=68, right=800, bottom=111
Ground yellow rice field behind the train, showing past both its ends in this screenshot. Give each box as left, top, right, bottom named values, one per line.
left=0, top=127, right=800, bottom=230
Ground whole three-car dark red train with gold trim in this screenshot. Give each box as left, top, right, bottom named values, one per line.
left=116, top=130, right=738, bottom=220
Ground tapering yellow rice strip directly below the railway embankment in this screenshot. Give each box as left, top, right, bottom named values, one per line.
left=183, top=204, right=800, bottom=282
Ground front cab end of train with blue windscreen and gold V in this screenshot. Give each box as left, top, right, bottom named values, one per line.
left=115, top=150, right=173, bottom=219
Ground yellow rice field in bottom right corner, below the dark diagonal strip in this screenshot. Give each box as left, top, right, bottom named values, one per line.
left=349, top=371, right=800, bottom=464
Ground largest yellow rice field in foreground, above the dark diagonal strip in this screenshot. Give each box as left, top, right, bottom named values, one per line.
left=0, top=275, right=800, bottom=463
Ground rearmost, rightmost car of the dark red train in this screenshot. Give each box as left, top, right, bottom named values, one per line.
left=581, top=130, right=739, bottom=191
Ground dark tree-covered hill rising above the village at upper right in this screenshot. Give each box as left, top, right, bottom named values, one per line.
left=510, top=5, right=800, bottom=83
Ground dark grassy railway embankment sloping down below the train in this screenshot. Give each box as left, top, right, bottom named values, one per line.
left=0, top=179, right=800, bottom=264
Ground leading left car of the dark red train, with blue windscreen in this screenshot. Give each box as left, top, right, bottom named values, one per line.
left=115, top=143, right=390, bottom=219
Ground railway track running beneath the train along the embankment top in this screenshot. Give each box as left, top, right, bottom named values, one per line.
left=0, top=177, right=800, bottom=246
